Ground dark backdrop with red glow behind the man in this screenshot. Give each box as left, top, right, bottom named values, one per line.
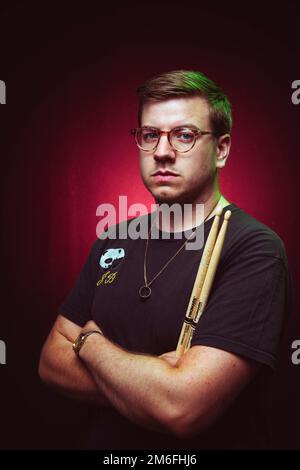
left=0, top=1, right=300, bottom=448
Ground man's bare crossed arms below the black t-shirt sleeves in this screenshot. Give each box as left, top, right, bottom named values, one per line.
left=39, top=316, right=258, bottom=438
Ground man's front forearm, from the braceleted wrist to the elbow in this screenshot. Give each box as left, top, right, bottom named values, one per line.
left=80, top=335, right=181, bottom=431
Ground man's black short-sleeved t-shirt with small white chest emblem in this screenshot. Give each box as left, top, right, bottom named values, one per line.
left=60, top=204, right=291, bottom=449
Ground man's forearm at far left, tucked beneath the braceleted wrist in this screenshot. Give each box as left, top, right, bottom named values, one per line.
left=39, top=335, right=109, bottom=406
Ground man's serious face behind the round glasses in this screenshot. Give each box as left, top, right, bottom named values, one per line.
left=140, top=96, right=223, bottom=204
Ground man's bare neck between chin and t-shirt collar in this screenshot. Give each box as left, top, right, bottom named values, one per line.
left=155, top=191, right=230, bottom=232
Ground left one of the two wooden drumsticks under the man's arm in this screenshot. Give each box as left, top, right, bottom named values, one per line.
left=176, top=206, right=222, bottom=357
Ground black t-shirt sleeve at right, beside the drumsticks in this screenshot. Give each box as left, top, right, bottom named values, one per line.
left=191, top=237, right=291, bottom=369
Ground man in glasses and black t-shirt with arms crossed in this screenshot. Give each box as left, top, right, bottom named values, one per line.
left=39, top=70, right=290, bottom=449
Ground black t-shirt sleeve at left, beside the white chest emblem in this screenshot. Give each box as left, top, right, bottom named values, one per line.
left=58, top=240, right=101, bottom=326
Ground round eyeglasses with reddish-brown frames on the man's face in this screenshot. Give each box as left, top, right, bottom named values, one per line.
left=130, top=127, right=214, bottom=153
